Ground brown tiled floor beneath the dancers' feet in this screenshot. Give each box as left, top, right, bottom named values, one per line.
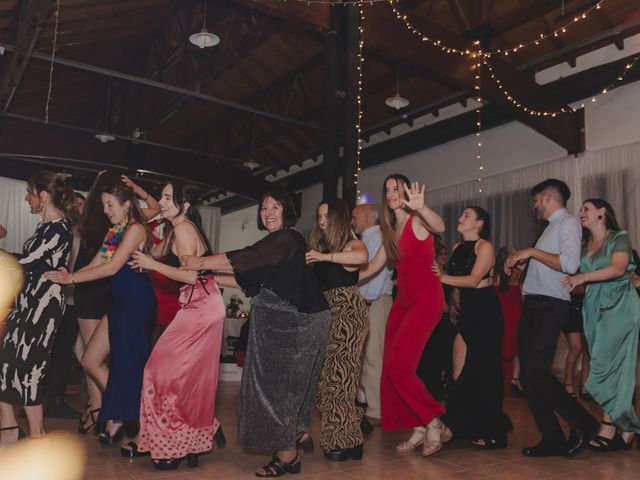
left=7, top=382, right=640, bottom=480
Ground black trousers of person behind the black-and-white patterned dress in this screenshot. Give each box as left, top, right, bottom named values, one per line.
left=46, top=305, right=78, bottom=399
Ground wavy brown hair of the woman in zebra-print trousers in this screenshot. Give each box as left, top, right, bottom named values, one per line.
left=308, top=198, right=353, bottom=253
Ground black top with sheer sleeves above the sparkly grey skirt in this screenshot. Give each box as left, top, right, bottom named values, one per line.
left=227, top=228, right=329, bottom=313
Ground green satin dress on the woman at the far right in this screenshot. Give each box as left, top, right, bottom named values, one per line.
left=580, top=231, right=640, bottom=432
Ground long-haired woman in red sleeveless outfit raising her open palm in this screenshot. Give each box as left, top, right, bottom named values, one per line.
left=360, top=174, right=451, bottom=456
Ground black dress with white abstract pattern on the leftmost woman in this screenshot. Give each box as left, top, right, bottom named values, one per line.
left=0, top=220, right=73, bottom=406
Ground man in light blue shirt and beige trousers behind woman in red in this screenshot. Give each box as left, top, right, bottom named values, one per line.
left=351, top=204, right=393, bottom=426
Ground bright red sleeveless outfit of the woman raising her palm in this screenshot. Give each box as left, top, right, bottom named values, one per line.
left=380, top=218, right=445, bottom=431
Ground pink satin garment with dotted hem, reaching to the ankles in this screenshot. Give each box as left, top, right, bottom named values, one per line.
left=137, top=276, right=225, bottom=459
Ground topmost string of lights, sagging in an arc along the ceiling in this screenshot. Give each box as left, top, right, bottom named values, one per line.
left=387, top=0, right=606, bottom=57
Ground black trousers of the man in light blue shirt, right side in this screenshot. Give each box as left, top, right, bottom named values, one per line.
left=518, top=295, right=593, bottom=445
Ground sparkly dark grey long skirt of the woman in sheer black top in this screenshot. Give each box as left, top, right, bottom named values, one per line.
left=238, top=288, right=331, bottom=450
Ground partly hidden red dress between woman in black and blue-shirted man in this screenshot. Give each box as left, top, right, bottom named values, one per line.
left=495, top=285, right=522, bottom=386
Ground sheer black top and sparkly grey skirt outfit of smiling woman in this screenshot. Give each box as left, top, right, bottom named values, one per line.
left=227, top=228, right=331, bottom=450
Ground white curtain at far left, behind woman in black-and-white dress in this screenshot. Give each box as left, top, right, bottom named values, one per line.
left=0, top=177, right=41, bottom=252
